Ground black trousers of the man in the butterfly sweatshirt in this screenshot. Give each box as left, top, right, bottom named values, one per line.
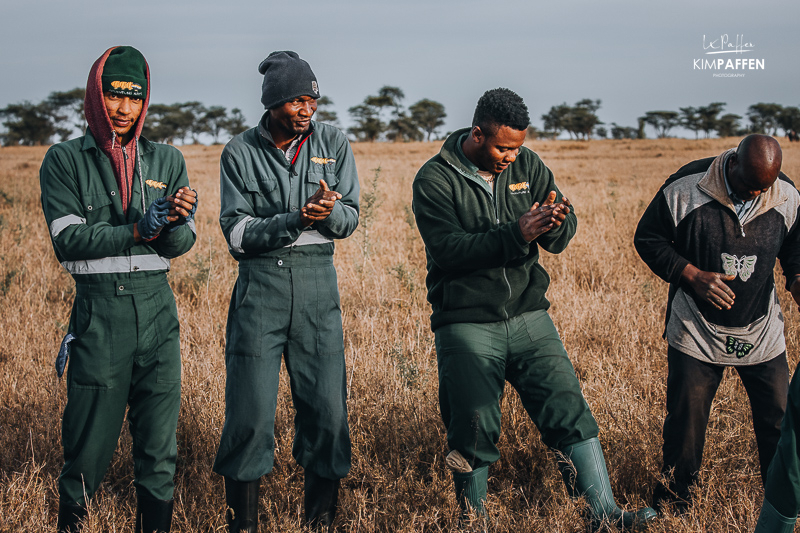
left=662, top=346, right=789, bottom=499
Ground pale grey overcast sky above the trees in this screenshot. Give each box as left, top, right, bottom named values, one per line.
left=0, top=0, right=800, bottom=136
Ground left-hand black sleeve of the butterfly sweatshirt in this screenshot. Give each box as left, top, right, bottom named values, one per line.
left=633, top=186, right=689, bottom=283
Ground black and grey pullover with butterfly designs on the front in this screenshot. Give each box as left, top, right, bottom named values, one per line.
left=634, top=151, right=800, bottom=365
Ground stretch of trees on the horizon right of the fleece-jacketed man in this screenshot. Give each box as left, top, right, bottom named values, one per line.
left=530, top=99, right=800, bottom=140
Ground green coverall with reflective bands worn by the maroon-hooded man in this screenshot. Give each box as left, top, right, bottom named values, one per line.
left=40, top=131, right=196, bottom=505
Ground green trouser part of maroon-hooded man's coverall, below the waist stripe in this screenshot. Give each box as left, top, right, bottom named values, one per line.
left=58, top=275, right=181, bottom=503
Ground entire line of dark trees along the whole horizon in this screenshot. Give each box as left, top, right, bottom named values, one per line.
left=0, top=85, right=800, bottom=146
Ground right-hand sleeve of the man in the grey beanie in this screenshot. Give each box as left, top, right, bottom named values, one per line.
left=314, top=135, right=359, bottom=239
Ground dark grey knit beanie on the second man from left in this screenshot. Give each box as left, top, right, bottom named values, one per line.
left=258, top=51, right=319, bottom=109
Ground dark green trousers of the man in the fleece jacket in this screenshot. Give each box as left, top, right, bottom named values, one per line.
left=435, top=311, right=598, bottom=468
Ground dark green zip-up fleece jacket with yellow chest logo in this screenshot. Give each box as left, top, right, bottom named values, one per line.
left=413, top=129, right=578, bottom=330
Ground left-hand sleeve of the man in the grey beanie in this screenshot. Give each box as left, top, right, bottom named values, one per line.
left=219, top=148, right=303, bottom=254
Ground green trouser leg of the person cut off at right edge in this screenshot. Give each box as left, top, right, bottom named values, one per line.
left=764, top=364, right=800, bottom=516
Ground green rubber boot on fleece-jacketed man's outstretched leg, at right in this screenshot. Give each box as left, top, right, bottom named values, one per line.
left=558, top=438, right=657, bottom=531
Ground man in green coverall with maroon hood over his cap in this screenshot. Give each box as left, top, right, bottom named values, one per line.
left=40, top=46, right=197, bottom=533
